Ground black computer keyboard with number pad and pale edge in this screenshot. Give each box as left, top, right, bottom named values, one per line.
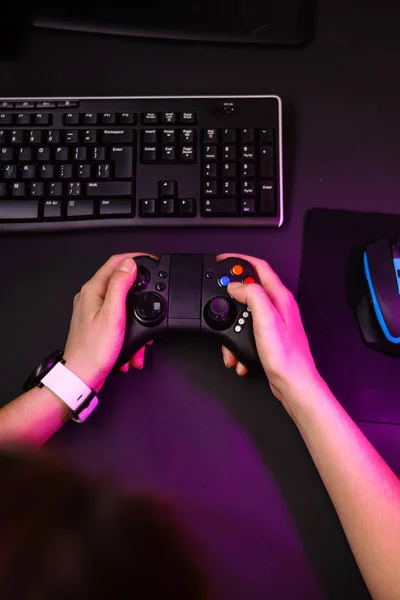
left=0, top=96, right=283, bottom=231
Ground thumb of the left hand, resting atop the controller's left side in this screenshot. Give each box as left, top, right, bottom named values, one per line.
left=103, top=258, right=137, bottom=318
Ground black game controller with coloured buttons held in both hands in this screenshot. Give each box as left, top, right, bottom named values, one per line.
left=116, top=254, right=260, bottom=369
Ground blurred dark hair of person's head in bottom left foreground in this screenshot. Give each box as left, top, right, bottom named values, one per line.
left=0, top=449, right=208, bottom=600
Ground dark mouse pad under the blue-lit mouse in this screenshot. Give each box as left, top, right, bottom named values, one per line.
left=299, top=209, right=400, bottom=425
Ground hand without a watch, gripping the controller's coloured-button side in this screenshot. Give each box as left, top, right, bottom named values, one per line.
left=217, top=254, right=318, bottom=403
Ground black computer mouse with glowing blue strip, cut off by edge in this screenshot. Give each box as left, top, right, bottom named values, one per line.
left=356, top=239, right=400, bottom=356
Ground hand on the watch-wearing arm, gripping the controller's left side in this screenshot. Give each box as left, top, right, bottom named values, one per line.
left=64, top=252, right=154, bottom=391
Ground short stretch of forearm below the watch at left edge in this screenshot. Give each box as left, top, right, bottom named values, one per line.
left=0, top=387, right=71, bottom=446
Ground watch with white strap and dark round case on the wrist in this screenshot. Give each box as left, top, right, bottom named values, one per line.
left=23, top=350, right=99, bottom=423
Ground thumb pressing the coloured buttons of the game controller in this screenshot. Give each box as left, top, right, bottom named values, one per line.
left=228, top=281, right=276, bottom=335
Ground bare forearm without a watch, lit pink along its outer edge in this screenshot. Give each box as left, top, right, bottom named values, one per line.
left=289, top=378, right=400, bottom=600
